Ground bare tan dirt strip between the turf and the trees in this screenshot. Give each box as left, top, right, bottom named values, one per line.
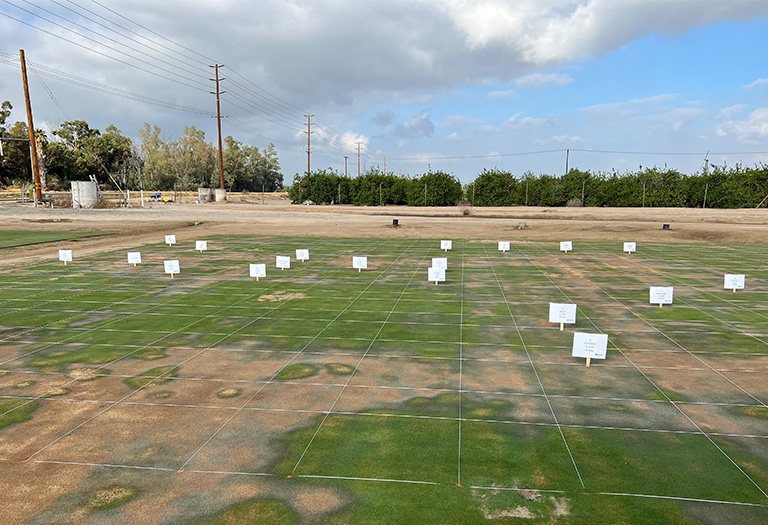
left=0, top=195, right=768, bottom=267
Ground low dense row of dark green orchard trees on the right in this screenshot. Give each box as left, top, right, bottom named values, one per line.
left=289, top=164, right=768, bottom=208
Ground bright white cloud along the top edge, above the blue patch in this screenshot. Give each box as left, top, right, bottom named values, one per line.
left=444, top=0, right=768, bottom=65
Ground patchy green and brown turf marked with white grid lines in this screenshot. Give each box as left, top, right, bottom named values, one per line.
left=0, top=236, right=768, bottom=523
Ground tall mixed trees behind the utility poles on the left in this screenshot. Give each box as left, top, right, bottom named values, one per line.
left=0, top=101, right=283, bottom=191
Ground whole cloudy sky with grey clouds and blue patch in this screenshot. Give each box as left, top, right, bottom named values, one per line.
left=0, top=0, right=768, bottom=182
